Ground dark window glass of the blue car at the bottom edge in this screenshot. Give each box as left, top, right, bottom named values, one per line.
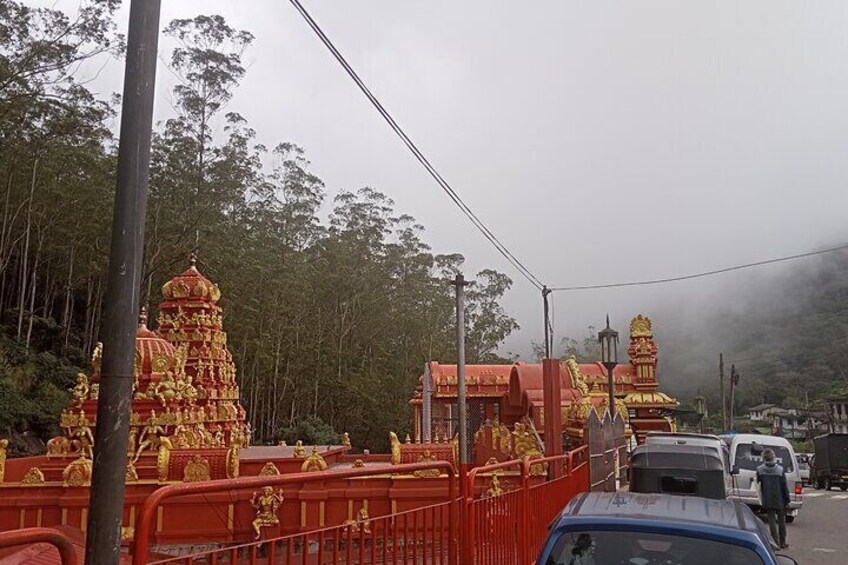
left=545, top=530, right=763, bottom=565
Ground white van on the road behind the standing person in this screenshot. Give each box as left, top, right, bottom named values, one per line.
left=721, top=434, right=804, bottom=522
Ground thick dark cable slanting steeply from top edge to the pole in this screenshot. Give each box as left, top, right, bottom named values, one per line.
left=290, top=0, right=544, bottom=290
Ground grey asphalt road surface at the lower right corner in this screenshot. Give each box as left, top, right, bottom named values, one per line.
left=783, top=489, right=848, bottom=565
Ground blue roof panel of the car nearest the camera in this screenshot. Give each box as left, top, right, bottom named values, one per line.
left=557, top=492, right=762, bottom=536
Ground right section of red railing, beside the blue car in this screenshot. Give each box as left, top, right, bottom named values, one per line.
left=460, top=447, right=589, bottom=565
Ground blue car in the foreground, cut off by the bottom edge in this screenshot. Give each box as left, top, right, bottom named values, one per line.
left=536, top=492, right=797, bottom=565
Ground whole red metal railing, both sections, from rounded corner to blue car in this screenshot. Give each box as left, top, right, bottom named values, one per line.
left=133, top=447, right=589, bottom=565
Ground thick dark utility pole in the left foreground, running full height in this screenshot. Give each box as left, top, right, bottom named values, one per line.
left=85, top=0, right=161, bottom=565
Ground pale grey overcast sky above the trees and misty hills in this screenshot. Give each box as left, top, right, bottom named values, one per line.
left=76, top=0, right=848, bottom=352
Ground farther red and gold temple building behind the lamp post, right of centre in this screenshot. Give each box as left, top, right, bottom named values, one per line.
left=410, top=315, right=678, bottom=465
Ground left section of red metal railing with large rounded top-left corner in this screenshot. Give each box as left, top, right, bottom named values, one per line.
left=132, top=461, right=458, bottom=565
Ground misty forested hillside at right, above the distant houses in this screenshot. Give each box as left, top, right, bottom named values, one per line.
left=658, top=251, right=848, bottom=415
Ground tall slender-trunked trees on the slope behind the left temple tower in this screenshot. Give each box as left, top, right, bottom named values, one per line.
left=0, top=0, right=518, bottom=453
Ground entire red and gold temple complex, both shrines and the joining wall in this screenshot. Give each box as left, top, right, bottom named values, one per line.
left=0, top=261, right=677, bottom=551
